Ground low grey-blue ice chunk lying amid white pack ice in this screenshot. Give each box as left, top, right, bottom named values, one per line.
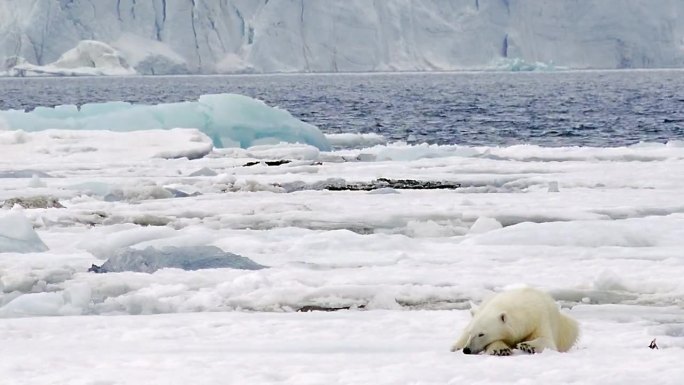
left=93, top=246, right=266, bottom=273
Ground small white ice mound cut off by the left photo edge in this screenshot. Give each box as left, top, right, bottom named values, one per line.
left=0, top=210, right=48, bottom=253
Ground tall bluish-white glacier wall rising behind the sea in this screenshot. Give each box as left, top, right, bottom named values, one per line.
left=0, top=0, right=684, bottom=74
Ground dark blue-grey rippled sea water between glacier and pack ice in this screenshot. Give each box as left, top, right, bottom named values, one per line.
left=0, top=71, right=684, bottom=147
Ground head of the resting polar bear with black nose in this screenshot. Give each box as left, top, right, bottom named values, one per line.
left=461, top=308, right=512, bottom=354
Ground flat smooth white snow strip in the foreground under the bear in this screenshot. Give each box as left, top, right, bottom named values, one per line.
left=0, top=305, right=684, bottom=385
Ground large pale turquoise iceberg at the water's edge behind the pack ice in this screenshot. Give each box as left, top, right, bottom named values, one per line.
left=0, top=94, right=330, bottom=151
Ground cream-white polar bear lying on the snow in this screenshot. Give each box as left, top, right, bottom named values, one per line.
left=451, top=287, right=579, bottom=356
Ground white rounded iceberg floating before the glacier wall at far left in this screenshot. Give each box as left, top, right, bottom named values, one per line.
left=5, top=40, right=137, bottom=76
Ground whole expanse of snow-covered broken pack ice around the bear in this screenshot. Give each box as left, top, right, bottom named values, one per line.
left=0, top=125, right=684, bottom=384
